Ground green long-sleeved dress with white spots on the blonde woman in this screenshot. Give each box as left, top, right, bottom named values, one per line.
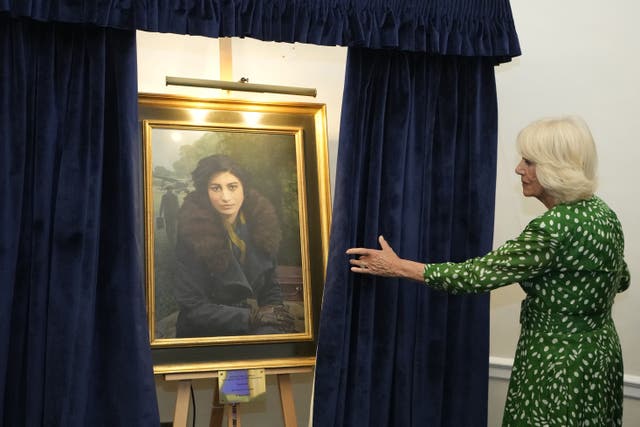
left=424, top=196, right=630, bottom=427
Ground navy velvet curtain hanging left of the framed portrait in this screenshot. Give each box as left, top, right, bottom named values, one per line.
left=0, top=14, right=159, bottom=427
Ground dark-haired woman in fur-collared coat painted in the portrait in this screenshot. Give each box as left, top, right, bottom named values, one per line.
left=175, top=155, right=294, bottom=338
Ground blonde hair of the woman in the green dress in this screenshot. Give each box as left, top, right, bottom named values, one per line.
left=517, top=116, right=598, bottom=203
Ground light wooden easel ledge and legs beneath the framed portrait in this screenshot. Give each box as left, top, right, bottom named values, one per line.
left=160, top=357, right=315, bottom=427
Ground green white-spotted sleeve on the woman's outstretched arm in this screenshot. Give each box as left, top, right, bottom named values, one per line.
left=424, top=215, right=559, bottom=294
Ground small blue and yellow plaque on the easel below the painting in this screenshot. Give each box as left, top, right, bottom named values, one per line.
left=218, top=369, right=267, bottom=403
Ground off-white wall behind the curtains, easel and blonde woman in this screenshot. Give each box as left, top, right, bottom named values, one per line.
left=138, top=0, right=640, bottom=426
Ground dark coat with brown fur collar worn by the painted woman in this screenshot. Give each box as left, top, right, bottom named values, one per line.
left=175, top=191, right=282, bottom=338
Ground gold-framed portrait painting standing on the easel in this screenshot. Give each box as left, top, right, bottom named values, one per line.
left=138, top=93, right=331, bottom=373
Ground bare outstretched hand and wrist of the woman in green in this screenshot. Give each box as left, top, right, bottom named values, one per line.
left=347, top=236, right=425, bottom=282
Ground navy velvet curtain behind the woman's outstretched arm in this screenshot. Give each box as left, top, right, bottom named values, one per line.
left=313, top=48, right=497, bottom=427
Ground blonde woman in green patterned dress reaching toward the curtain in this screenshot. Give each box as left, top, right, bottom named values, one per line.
left=347, top=117, right=630, bottom=427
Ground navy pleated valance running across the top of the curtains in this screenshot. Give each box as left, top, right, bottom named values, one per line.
left=0, top=0, right=520, bottom=62
